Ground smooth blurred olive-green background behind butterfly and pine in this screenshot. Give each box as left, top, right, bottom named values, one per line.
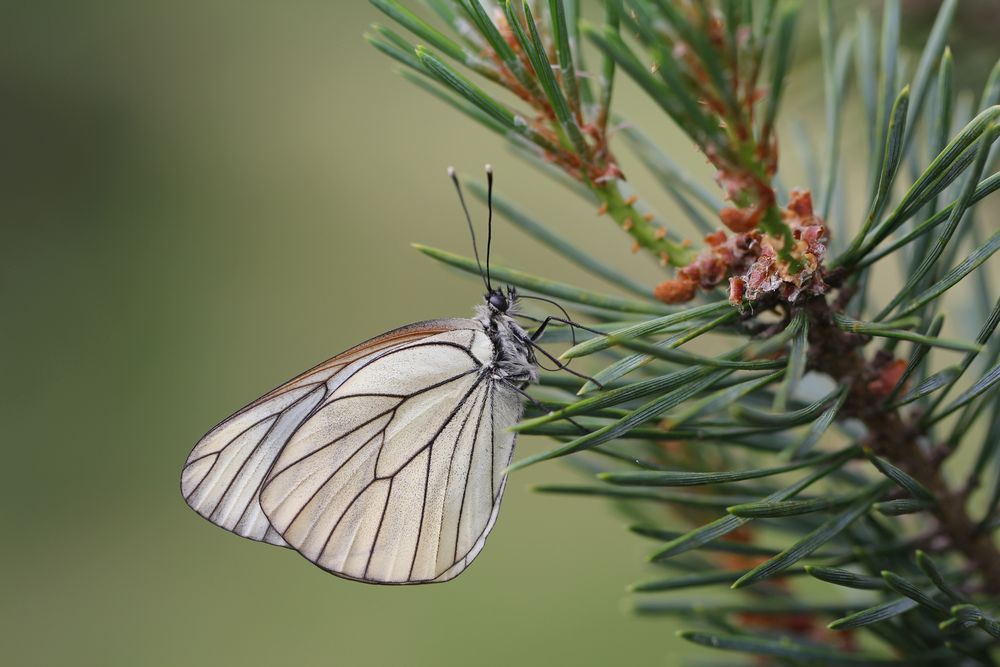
left=0, top=0, right=997, bottom=665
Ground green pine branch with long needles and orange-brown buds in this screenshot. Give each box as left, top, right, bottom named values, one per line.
left=369, top=0, right=1000, bottom=665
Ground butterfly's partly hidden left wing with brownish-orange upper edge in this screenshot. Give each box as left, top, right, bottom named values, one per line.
left=181, top=320, right=470, bottom=546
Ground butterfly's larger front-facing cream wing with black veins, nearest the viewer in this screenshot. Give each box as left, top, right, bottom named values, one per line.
left=261, top=328, right=520, bottom=584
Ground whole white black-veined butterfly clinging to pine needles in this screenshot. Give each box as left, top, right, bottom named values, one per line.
left=181, top=165, right=584, bottom=584
